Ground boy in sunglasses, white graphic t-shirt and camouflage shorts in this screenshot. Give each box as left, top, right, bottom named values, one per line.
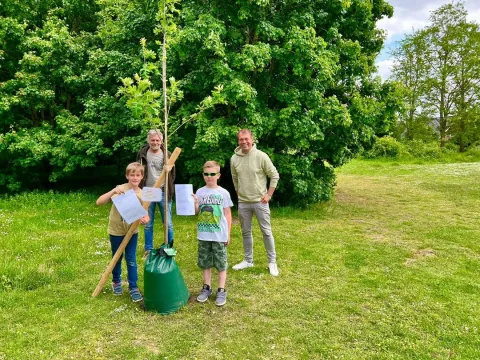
left=193, top=161, right=233, bottom=306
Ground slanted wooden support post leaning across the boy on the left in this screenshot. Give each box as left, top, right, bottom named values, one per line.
left=92, top=148, right=182, bottom=297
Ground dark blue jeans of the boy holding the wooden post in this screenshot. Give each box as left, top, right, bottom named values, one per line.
left=110, top=233, right=138, bottom=290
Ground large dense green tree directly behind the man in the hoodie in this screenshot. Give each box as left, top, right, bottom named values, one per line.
left=159, top=0, right=395, bottom=204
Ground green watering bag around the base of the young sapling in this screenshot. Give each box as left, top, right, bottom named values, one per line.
left=144, top=245, right=189, bottom=315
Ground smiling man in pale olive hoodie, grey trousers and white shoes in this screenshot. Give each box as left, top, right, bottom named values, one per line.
left=230, top=129, right=280, bottom=276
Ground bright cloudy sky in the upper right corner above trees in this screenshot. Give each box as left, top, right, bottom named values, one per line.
left=377, top=0, right=480, bottom=79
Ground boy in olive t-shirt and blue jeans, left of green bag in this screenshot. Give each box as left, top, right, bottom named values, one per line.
left=97, top=162, right=149, bottom=302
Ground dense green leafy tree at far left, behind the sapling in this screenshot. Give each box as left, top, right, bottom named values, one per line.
left=0, top=0, right=155, bottom=189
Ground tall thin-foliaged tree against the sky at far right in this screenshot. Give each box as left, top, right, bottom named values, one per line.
left=393, top=2, right=480, bottom=151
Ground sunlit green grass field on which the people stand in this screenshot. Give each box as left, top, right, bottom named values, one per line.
left=0, top=160, right=480, bottom=360
